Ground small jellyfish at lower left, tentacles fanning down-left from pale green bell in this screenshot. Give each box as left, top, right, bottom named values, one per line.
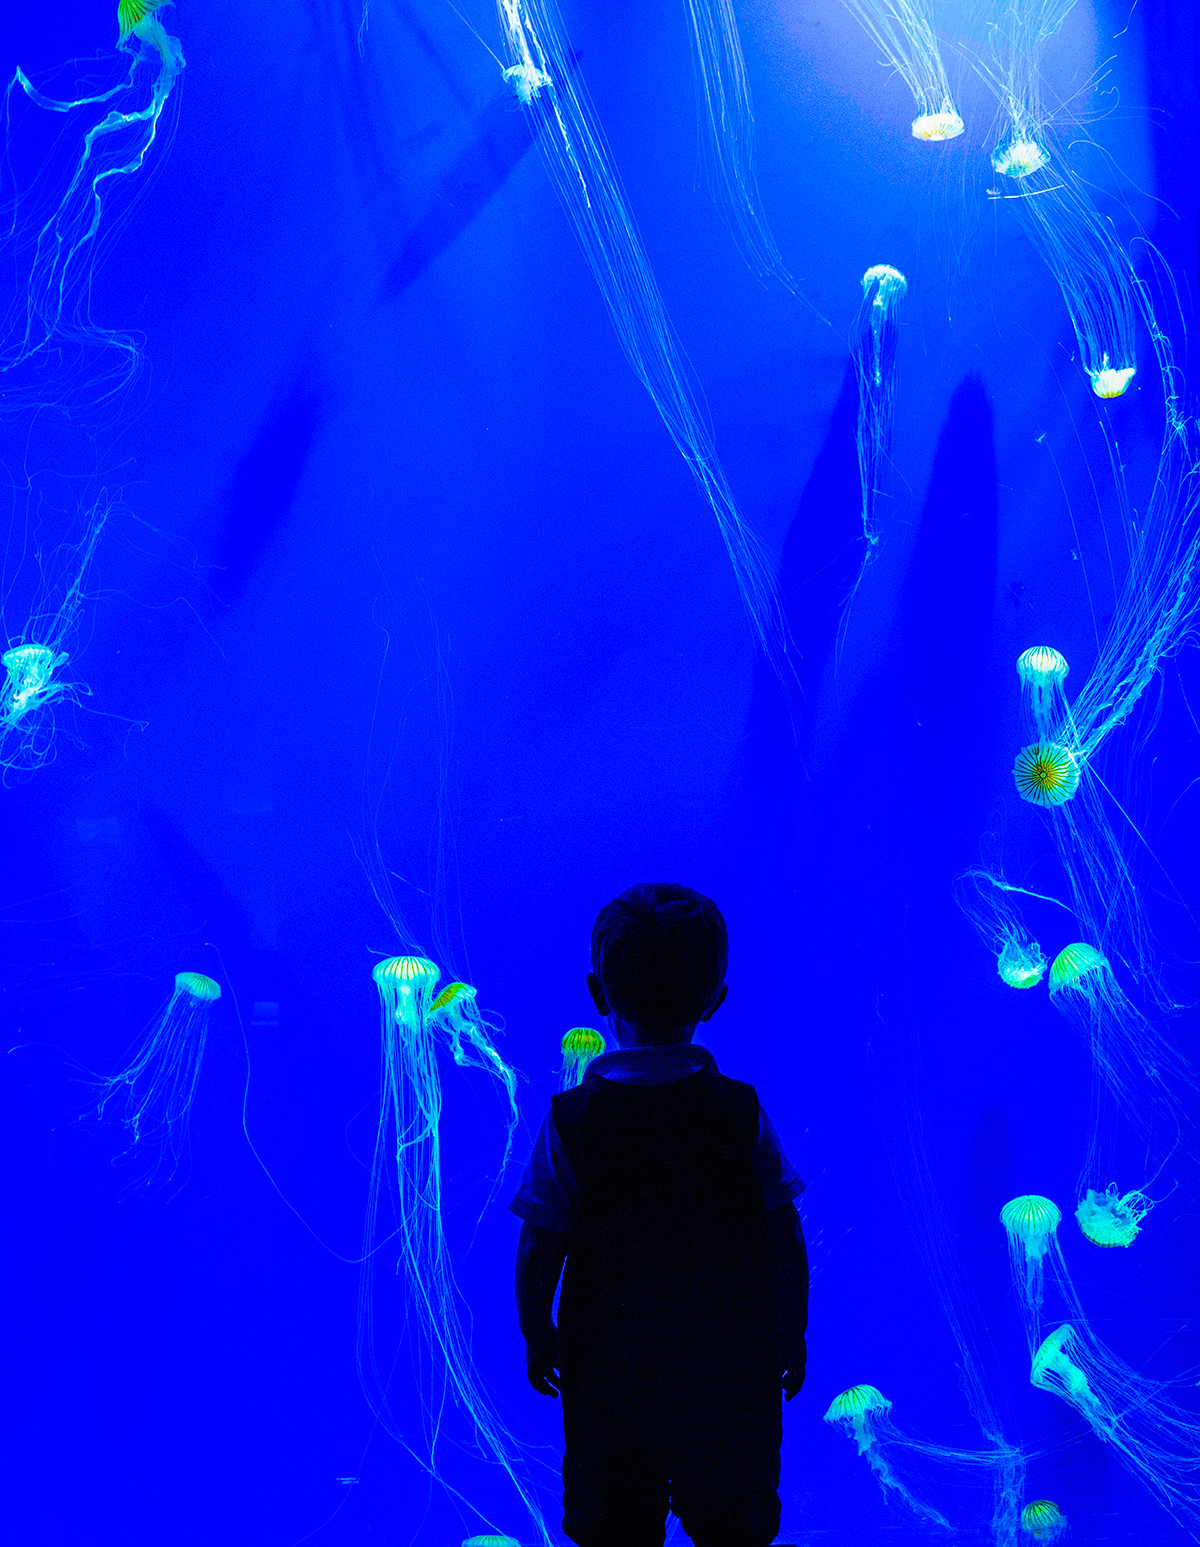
left=97, top=972, right=221, bottom=1187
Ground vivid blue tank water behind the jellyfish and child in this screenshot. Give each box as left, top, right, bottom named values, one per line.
left=0, top=0, right=1200, bottom=1547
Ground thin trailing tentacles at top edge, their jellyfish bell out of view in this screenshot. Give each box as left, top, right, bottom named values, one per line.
left=684, top=0, right=796, bottom=292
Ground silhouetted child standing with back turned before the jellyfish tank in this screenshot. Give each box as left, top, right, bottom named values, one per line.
left=512, top=883, right=809, bottom=1547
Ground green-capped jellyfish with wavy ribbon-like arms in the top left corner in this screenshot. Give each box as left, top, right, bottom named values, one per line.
left=0, top=0, right=184, bottom=413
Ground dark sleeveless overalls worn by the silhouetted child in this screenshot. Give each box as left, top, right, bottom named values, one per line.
left=552, top=1069, right=782, bottom=1547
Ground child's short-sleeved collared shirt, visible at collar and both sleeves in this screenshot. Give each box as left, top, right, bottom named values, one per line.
left=509, top=1043, right=804, bottom=1235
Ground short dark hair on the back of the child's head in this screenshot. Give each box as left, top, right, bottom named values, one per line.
left=592, top=882, right=730, bottom=1043
